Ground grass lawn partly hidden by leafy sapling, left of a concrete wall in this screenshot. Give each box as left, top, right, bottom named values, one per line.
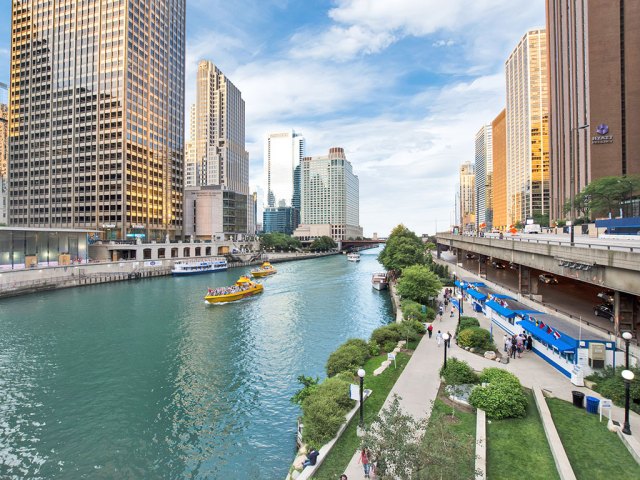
left=423, top=398, right=476, bottom=479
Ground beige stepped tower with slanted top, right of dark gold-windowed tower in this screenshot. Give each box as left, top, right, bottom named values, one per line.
left=184, top=60, right=251, bottom=240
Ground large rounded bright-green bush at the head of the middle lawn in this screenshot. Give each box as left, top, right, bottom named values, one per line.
left=469, top=381, right=527, bottom=420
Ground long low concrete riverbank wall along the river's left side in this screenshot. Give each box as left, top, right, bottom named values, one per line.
left=0, top=252, right=336, bottom=298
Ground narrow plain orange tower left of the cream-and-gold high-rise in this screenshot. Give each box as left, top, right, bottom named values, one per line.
left=491, top=109, right=509, bottom=231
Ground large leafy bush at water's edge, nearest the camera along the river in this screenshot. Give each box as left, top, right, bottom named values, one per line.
left=302, top=378, right=355, bottom=445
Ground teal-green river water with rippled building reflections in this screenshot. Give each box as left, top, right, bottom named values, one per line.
left=0, top=249, right=393, bottom=479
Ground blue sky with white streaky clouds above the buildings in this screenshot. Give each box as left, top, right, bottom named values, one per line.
left=0, top=0, right=545, bottom=236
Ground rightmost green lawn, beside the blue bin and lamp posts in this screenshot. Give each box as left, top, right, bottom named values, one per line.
left=547, top=398, right=640, bottom=480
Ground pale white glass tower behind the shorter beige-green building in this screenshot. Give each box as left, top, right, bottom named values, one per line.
left=264, top=130, right=305, bottom=207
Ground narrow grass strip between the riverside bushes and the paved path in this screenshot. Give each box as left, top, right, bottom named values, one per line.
left=313, top=340, right=418, bottom=480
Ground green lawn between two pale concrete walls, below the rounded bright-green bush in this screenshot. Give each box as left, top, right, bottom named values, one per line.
left=487, top=390, right=556, bottom=480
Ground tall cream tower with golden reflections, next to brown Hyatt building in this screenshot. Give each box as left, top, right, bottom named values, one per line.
left=505, top=29, right=549, bottom=224
